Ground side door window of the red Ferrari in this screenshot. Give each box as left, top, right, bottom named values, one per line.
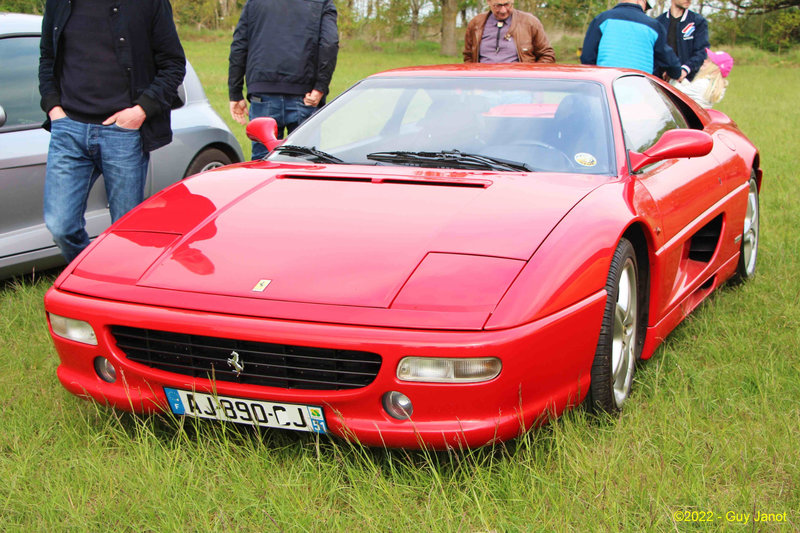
left=614, top=76, right=688, bottom=152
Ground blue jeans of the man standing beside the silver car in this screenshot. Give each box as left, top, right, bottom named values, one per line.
left=44, top=117, right=150, bottom=262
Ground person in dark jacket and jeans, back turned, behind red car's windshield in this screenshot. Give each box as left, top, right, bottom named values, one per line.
left=228, top=0, right=339, bottom=159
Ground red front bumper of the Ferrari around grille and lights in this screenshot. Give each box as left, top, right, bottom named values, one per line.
left=45, top=288, right=605, bottom=449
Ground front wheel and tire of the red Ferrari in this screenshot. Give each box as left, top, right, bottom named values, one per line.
left=586, top=238, right=645, bottom=414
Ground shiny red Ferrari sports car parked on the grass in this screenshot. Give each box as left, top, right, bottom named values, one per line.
left=45, top=65, right=761, bottom=448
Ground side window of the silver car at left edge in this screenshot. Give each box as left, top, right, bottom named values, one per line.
left=0, top=37, right=45, bottom=131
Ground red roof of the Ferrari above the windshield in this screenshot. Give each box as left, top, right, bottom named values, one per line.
left=370, top=63, right=643, bottom=83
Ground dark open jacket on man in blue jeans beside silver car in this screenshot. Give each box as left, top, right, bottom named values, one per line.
left=39, top=0, right=186, bottom=152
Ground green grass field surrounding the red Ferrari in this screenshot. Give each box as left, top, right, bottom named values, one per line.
left=0, top=35, right=800, bottom=532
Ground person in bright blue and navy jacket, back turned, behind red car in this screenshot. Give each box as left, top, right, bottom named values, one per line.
left=581, top=0, right=683, bottom=79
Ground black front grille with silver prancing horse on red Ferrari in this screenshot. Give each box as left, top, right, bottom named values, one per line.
left=111, top=326, right=381, bottom=390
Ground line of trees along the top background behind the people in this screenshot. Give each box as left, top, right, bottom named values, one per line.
left=6, top=0, right=800, bottom=55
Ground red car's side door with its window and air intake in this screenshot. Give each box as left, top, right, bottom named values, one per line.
left=614, top=76, right=730, bottom=316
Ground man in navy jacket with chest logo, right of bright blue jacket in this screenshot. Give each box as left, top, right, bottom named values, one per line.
left=656, top=0, right=709, bottom=81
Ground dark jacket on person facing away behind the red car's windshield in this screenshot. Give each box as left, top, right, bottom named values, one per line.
left=228, top=0, right=339, bottom=102
